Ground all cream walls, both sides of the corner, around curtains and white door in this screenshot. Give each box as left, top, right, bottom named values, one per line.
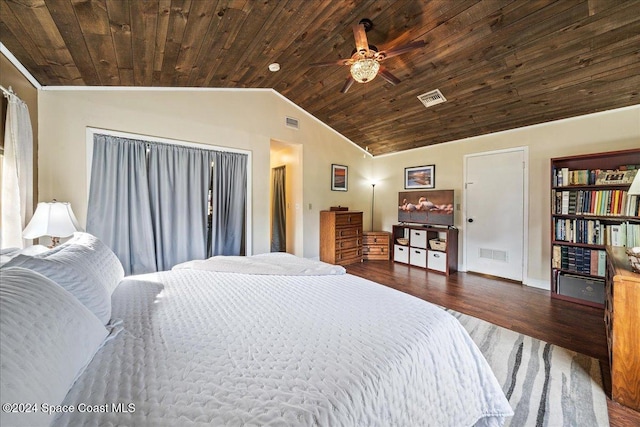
left=39, top=89, right=640, bottom=288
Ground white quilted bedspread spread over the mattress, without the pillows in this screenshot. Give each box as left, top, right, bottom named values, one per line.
left=54, top=269, right=512, bottom=427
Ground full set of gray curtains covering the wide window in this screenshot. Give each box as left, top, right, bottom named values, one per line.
left=87, top=134, right=248, bottom=274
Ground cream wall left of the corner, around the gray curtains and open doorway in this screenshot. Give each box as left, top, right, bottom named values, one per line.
left=38, top=88, right=372, bottom=258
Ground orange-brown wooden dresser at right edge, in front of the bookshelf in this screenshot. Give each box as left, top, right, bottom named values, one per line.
left=604, top=246, right=640, bottom=411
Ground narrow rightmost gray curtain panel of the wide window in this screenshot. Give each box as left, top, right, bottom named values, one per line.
left=209, top=152, right=248, bottom=255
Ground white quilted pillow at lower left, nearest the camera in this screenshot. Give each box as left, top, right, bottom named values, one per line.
left=0, top=268, right=107, bottom=426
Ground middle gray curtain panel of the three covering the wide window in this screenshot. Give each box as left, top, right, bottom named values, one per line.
left=148, top=143, right=215, bottom=271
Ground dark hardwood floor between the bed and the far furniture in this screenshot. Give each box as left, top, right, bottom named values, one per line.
left=346, top=261, right=640, bottom=427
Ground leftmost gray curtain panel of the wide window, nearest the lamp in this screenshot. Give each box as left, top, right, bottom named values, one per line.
left=87, top=135, right=156, bottom=274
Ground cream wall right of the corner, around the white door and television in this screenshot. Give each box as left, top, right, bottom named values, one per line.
left=373, top=106, right=640, bottom=289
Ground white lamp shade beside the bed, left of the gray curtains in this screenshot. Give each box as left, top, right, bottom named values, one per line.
left=22, top=202, right=82, bottom=239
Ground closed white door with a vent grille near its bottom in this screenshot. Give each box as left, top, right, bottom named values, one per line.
left=464, top=148, right=527, bottom=282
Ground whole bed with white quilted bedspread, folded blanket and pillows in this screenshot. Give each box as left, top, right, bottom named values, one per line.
left=0, top=233, right=513, bottom=427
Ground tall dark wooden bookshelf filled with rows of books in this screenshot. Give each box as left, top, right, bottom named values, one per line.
left=551, top=149, right=640, bottom=308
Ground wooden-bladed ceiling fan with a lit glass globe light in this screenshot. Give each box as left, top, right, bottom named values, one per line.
left=310, top=18, right=426, bottom=93
